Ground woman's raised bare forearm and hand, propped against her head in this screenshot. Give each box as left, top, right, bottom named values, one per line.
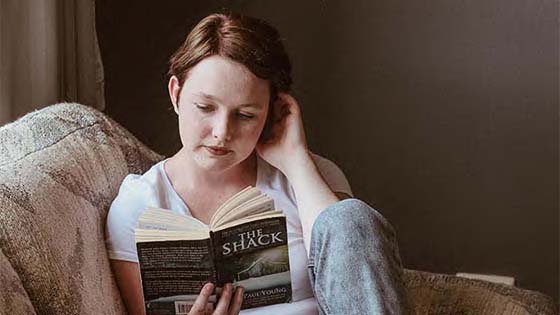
left=257, top=93, right=347, bottom=253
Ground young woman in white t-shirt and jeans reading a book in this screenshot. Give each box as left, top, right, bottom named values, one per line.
left=107, top=14, right=410, bottom=315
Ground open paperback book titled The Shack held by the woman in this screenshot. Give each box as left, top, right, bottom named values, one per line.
left=135, top=187, right=292, bottom=315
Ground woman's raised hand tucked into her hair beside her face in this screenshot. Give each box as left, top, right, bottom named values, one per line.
left=256, top=93, right=309, bottom=174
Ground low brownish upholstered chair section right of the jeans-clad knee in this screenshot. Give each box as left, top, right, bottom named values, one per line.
left=404, top=269, right=558, bottom=315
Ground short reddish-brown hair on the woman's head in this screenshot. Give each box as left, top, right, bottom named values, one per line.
left=168, top=13, right=292, bottom=102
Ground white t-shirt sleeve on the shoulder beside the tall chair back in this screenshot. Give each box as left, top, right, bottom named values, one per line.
left=105, top=174, right=151, bottom=262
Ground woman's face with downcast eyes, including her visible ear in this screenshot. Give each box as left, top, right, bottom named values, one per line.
left=169, top=56, right=270, bottom=171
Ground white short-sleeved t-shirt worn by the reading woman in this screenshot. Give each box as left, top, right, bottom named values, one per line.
left=105, top=155, right=352, bottom=315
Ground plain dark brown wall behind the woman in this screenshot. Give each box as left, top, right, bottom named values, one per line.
left=97, top=0, right=559, bottom=300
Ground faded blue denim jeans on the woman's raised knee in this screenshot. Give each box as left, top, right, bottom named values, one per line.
left=308, top=199, right=413, bottom=315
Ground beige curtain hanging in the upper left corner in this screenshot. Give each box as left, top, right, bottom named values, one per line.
left=0, top=0, right=105, bottom=125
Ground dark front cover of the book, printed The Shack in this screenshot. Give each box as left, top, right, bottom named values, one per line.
left=212, top=217, right=292, bottom=309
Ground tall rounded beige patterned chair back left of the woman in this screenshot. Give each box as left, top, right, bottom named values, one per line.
left=0, top=103, right=162, bottom=314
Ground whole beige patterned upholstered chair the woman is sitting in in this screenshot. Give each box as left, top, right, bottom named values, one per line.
left=0, top=104, right=558, bottom=315
